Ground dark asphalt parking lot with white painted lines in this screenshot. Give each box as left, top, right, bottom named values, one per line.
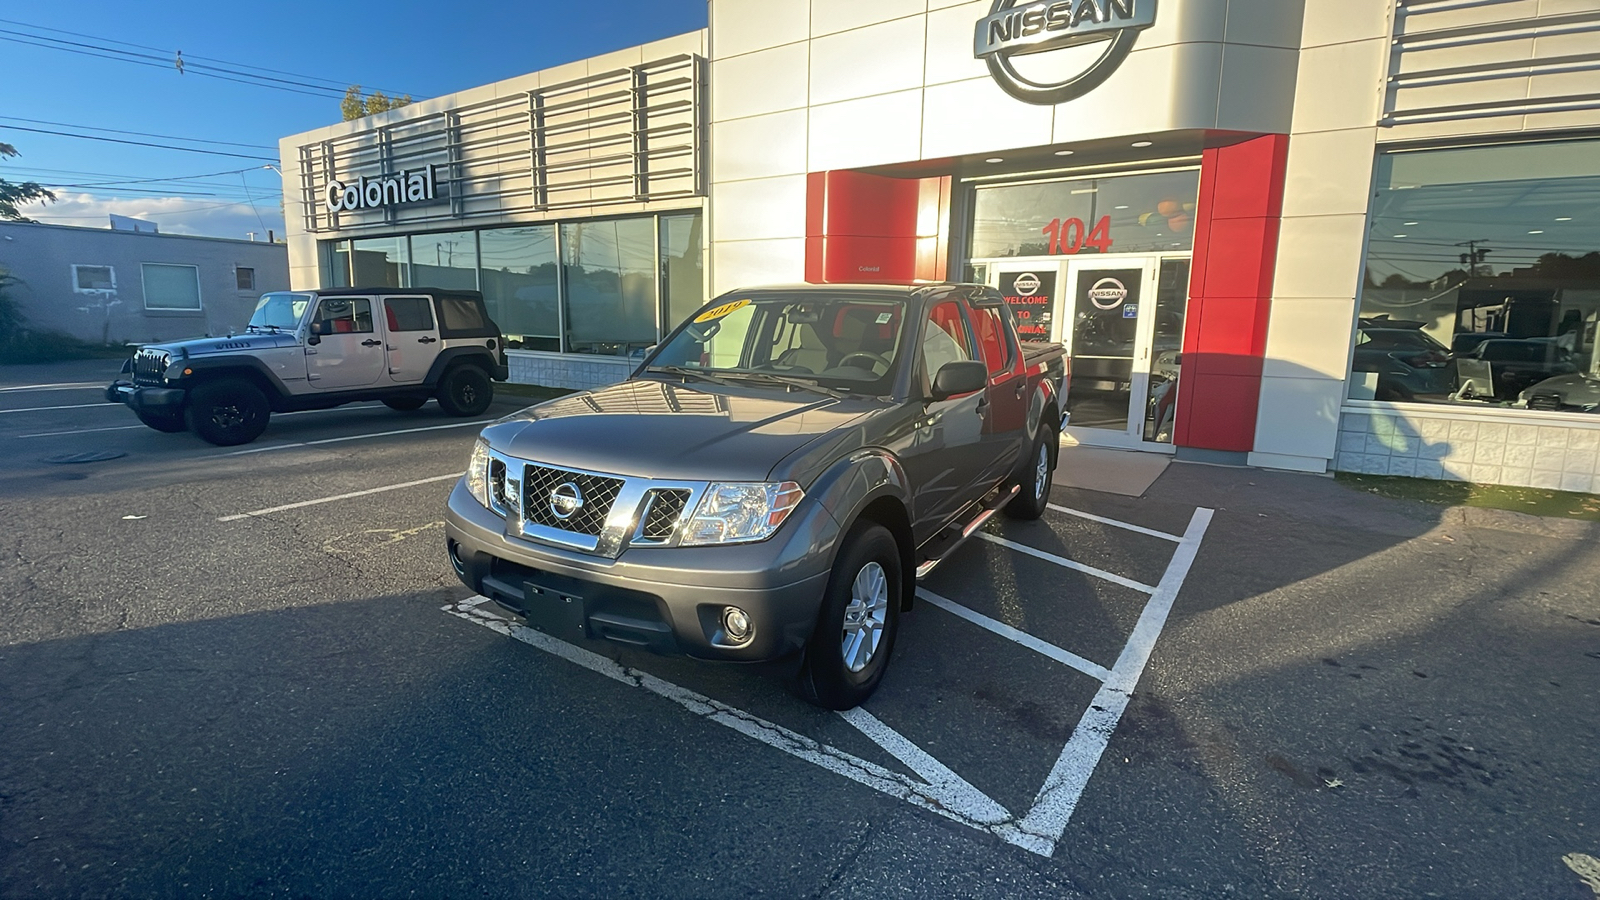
left=0, top=362, right=1600, bottom=898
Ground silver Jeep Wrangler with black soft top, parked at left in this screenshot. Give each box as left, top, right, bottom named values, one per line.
left=106, top=288, right=507, bottom=447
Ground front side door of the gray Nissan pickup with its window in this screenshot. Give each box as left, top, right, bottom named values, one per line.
left=899, top=299, right=989, bottom=541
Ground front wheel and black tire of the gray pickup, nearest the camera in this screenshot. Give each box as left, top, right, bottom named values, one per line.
left=800, top=522, right=902, bottom=709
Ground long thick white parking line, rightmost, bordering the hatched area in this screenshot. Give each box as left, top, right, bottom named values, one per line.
left=1019, top=508, right=1211, bottom=854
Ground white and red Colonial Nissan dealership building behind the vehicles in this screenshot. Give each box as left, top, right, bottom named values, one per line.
left=282, top=0, right=1600, bottom=492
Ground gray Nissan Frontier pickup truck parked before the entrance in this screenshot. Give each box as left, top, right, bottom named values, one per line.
left=445, top=283, right=1067, bottom=709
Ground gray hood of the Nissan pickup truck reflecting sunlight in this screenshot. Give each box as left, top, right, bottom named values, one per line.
left=483, top=374, right=882, bottom=482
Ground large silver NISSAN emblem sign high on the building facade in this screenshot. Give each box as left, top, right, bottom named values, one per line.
left=973, top=0, right=1155, bottom=106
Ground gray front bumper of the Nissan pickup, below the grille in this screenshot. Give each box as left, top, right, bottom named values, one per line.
left=445, top=482, right=840, bottom=663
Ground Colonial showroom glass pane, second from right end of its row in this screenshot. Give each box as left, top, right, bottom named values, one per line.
left=562, top=218, right=658, bottom=356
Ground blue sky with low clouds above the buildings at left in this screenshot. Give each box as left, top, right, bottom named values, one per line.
left=0, top=0, right=706, bottom=239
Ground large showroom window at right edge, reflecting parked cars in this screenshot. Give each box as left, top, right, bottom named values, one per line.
left=1349, top=141, right=1600, bottom=413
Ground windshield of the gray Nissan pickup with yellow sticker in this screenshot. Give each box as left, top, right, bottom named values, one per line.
left=645, top=293, right=906, bottom=394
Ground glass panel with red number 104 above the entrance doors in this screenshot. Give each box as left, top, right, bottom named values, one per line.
left=971, top=170, right=1200, bottom=259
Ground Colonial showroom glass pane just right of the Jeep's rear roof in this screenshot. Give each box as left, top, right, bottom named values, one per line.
left=478, top=224, right=562, bottom=351
